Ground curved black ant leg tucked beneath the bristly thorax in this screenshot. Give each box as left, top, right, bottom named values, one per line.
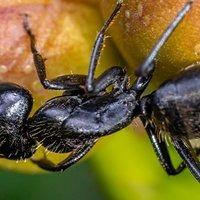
left=31, top=139, right=97, bottom=172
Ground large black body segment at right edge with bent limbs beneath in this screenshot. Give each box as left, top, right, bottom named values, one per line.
left=140, top=65, right=200, bottom=181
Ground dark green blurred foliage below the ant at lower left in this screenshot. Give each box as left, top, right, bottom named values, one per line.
left=0, top=162, right=106, bottom=200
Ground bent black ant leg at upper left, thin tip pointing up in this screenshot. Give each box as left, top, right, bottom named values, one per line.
left=23, top=14, right=86, bottom=90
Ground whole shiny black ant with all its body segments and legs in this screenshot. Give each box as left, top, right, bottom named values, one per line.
left=0, top=1, right=200, bottom=181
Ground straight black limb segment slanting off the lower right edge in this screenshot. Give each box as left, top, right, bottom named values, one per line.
left=172, top=137, right=200, bottom=182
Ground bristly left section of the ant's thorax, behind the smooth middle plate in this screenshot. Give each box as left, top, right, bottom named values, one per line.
left=29, top=96, right=83, bottom=153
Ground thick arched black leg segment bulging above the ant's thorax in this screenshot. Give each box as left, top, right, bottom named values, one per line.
left=93, top=66, right=127, bottom=94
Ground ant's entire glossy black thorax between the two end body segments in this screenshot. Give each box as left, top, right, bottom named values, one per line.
left=29, top=67, right=139, bottom=152
